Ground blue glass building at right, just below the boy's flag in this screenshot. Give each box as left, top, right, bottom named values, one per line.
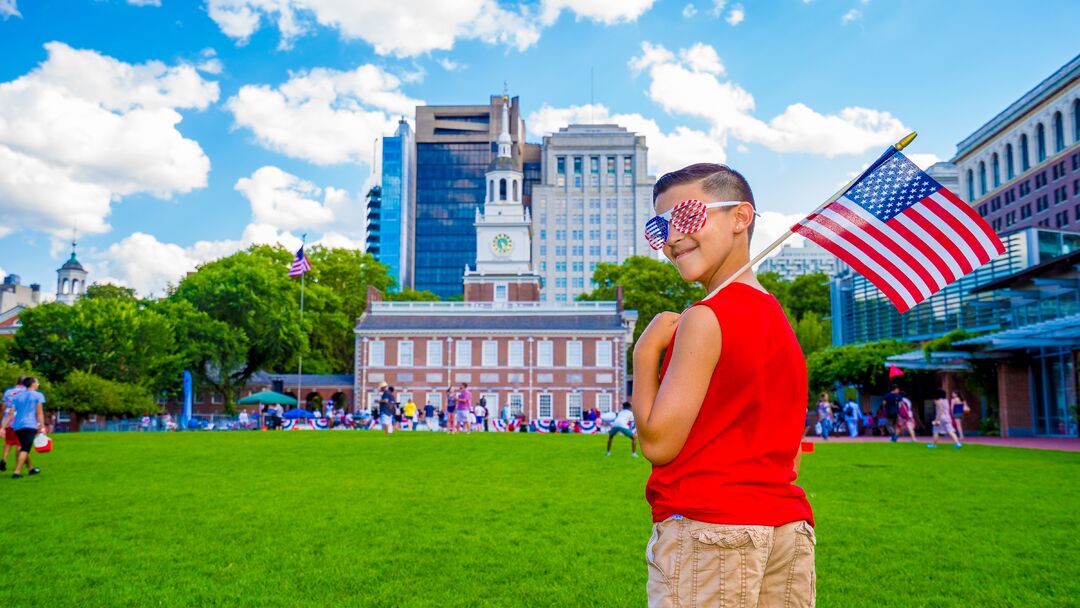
left=832, top=228, right=1080, bottom=346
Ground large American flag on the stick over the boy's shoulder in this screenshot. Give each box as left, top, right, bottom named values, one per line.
left=792, top=148, right=1004, bottom=312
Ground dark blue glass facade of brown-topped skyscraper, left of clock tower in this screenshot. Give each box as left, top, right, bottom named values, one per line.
left=415, top=141, right=495, bottom=298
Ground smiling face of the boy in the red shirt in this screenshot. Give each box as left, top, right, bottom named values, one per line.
left=654, top=181, right=754, bottom=283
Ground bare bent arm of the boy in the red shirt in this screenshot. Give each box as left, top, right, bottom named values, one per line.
left=633, top=307, right=721, bottom=464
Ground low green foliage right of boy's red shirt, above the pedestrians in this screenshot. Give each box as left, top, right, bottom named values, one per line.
left=807, top=340, right=914, bottom=394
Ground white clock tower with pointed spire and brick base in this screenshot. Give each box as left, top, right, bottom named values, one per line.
left=464, top=95, right=540, bottom=302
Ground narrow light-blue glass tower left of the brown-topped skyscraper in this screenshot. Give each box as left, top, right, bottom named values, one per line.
left=373, top=119, right=414, bottom=288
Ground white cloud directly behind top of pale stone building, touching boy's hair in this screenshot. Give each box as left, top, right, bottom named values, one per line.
left=525, top=104, right=727, bottom=174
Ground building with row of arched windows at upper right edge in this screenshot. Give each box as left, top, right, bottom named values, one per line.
left=951, top=55, right=1080, bottom=232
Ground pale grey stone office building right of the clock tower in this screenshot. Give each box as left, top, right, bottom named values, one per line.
left=531, top=124, right=656, bottom=301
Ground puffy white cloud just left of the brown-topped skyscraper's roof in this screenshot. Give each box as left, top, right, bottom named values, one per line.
left=226, top=65, right=423, bottom=165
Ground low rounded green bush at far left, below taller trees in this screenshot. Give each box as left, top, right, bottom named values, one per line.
left=49, top=370, right=160, bottom=416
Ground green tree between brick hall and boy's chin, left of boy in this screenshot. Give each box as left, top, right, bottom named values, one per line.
left=578, top=256, right=705, bottom=360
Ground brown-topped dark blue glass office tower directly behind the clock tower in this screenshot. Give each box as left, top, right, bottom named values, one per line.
left=410, top=95, right=528, bottom=297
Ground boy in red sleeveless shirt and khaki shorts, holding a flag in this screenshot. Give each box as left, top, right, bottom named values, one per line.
left=633, top=164, right=816, bottom=606
